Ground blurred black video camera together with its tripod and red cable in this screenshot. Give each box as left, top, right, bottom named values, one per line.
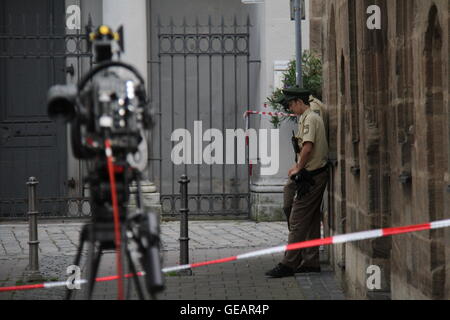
left=48, top=26, right=164, bottom=298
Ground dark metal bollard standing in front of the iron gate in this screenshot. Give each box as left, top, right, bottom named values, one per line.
left=178, top=174, right=192, bottom=275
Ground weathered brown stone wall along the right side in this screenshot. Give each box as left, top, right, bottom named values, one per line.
left=318, top=0, right=450, bottom=299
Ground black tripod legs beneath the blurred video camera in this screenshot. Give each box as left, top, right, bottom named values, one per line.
left=66, top=173, right=164, bottom=300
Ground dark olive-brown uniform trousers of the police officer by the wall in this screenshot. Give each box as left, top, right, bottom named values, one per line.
left=282, top=170, right=328, bottom=270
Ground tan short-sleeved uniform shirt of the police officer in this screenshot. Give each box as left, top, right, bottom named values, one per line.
left=298, top=108, right=328, bottom=171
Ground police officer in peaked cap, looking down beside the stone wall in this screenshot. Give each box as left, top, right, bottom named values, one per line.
left=266, top=87, right=328, bottom=278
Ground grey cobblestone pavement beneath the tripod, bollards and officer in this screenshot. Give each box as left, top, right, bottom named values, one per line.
left=0, top=221, right=345, bottom=300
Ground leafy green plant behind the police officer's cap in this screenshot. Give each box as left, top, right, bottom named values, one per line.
left=267, top=51, right=322, bottom=128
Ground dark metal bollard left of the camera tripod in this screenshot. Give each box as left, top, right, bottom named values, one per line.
left=25, top=177, right=42, bottom=282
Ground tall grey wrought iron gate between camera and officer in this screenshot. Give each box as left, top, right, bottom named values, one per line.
left=150, top=17, right=251, bottom=217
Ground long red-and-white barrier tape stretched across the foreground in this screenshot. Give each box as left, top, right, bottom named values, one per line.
left=0, top=219, right=450, bottom=292
